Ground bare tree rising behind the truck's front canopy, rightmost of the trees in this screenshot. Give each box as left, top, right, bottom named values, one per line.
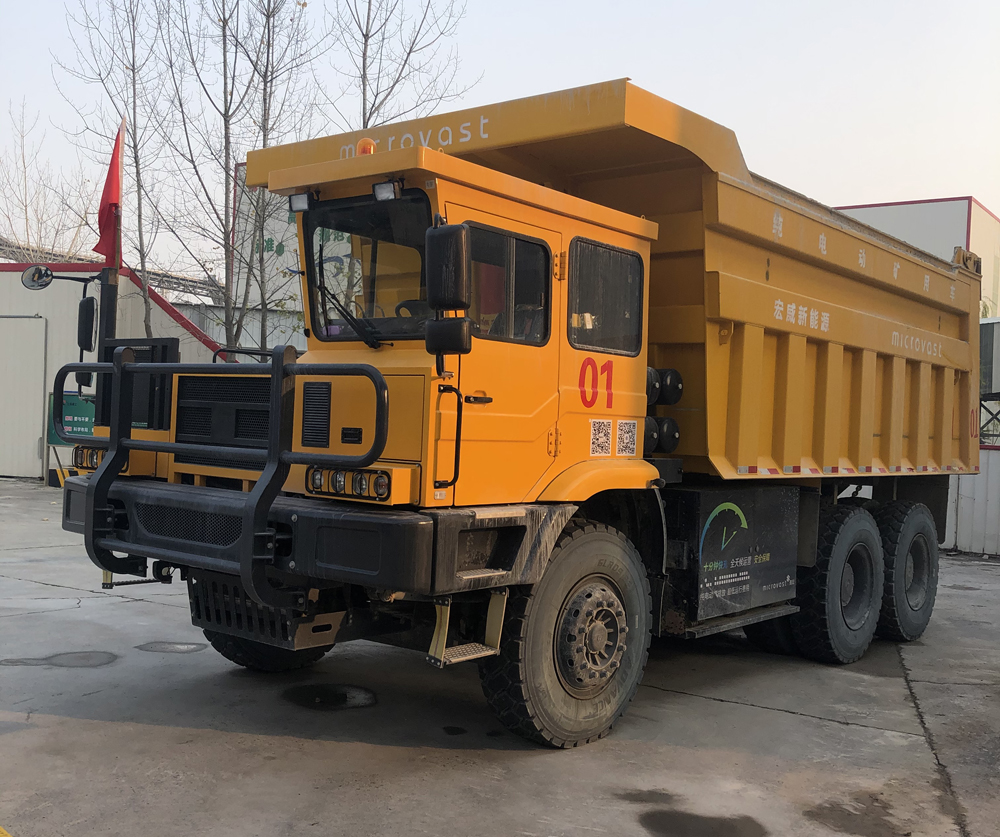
left=326, top=0, right=469, bottom=130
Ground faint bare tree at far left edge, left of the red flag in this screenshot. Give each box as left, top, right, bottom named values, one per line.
left=0, top=102, right=96, bottom=262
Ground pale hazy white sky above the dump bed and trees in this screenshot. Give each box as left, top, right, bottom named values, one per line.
left=0, top=0, right=1000, bottom=219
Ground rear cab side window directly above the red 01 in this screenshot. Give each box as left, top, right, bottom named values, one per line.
left=568, top=238, right=642, bottom=357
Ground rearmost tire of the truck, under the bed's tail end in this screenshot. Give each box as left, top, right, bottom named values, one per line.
left=875, top=500, right=938, bottom=642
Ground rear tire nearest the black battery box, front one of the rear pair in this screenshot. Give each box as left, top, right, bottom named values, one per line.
left=791, top=505, right=884, bottom=664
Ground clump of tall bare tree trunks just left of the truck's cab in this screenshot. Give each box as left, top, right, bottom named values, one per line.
left=158, top=0, right=315, bottom=346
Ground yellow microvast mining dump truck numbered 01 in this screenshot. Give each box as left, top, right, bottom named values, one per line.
left=50, top=81, right=980, bottom=747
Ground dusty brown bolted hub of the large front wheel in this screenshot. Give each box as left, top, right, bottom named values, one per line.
left=556, top=579, right=628, bottom=696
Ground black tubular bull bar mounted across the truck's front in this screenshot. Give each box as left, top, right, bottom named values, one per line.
left=53, top=346, right=389, bottom=610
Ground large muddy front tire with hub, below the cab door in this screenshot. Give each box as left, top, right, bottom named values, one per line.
left=480, top=521, right=652, bottom=747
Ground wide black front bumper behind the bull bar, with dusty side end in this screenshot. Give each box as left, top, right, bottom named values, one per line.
left=63, top=476, right=576, bottom=596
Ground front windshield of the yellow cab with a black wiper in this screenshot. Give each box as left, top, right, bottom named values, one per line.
left=304, top=189, right=431, bottom=345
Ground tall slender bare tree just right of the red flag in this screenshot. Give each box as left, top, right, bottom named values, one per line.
left=56, top=0, right=163, bottom=338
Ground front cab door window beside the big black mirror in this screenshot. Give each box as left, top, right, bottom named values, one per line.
left=469, top=227, right=550, bottom=345
